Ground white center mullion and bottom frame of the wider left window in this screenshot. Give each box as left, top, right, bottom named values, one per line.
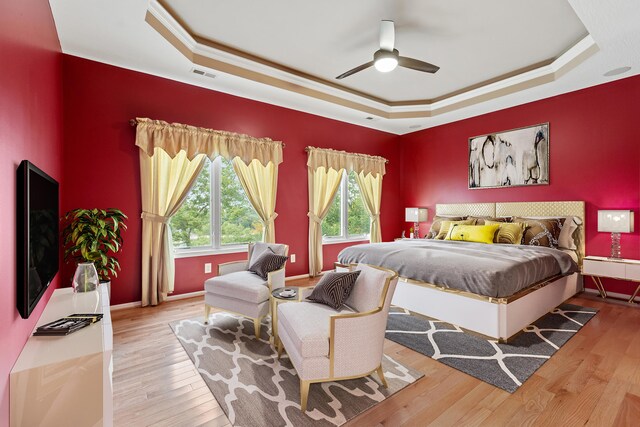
left=173, top=156, right=253, bottom=259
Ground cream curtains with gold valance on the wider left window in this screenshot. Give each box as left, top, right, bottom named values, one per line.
left=135, top=118, right=284, bottom=306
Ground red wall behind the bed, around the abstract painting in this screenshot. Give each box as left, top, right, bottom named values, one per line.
left=401, top=76, right=640, bottom=294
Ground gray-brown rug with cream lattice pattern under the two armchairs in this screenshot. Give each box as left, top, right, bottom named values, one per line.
left=170, top=313, right=423, bottom=427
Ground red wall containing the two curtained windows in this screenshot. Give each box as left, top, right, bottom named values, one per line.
left=63, top=55, right=402, bottom=304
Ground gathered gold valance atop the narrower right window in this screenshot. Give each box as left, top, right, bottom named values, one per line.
left=307, top=147, right=387, bottom=176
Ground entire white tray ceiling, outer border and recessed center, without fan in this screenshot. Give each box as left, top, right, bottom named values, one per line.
left=50, top=0, right=640, bottom=134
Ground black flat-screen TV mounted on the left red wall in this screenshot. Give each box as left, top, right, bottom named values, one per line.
left=16, top=160, right=59, bottom=319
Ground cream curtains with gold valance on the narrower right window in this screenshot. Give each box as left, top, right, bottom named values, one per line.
left=307, top=147, right=387, bottom=277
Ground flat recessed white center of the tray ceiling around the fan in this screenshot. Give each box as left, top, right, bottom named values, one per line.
left=166, top=0, right=587, bottom=101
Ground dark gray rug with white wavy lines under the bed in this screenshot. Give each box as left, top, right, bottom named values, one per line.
left=386, top=304, right=597, bottom=393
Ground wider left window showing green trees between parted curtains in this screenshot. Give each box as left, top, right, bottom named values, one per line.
left=171, top=157, right=262, bottom=255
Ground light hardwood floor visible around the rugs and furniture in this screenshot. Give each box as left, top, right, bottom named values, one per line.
left=112, top=280, right=640, bottom=426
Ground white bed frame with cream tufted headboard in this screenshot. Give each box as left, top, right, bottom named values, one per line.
left=392, top=202, right=585, bottom=341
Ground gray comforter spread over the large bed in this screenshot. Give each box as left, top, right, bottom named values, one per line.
left=338, top=239, right=578, bottom=298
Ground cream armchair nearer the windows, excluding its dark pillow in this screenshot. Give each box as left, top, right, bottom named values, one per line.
left=204, top=243, right=289, bottom=338
